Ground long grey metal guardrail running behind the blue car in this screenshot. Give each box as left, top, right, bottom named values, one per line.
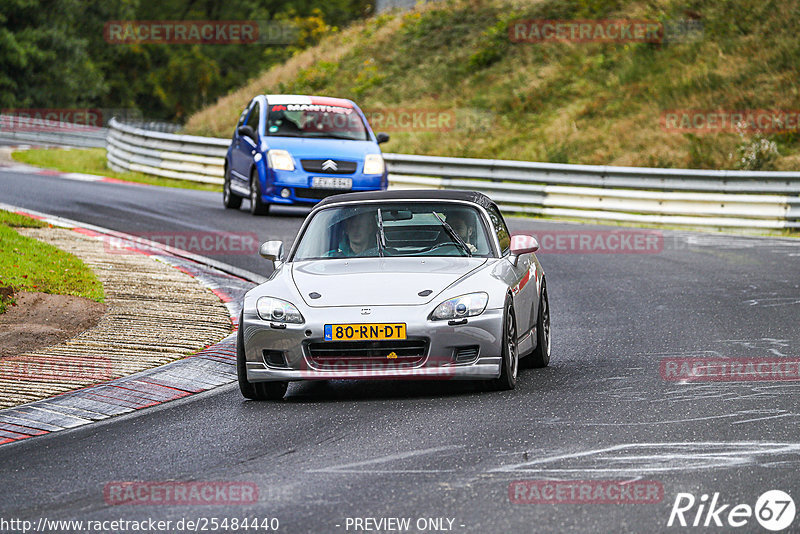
left=108, top=120, right=800, bottom=229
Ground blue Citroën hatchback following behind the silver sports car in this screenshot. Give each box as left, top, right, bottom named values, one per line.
left=223, top=95, right=389, bottom=215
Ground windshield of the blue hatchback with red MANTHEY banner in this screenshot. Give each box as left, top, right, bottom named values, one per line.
left=266, top=104, right=369, bottom=141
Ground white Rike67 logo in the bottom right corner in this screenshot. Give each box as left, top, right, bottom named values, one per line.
left=667, top=490, right=796, bottom=532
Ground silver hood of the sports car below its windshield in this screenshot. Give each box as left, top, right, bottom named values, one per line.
left=292, top=257, right=487, bottom=308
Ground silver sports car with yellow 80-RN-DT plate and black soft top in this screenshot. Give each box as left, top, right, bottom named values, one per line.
left=237, top=190, right=550, bottom=399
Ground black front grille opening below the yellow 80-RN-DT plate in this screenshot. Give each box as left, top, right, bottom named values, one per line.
left=306, top=339, right=428, bottom=367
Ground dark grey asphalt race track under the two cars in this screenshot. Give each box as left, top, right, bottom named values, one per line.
left=0, top=170, right=800, bottom=532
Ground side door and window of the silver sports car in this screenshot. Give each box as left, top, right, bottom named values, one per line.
left=487, top=206, right=538, bottom=338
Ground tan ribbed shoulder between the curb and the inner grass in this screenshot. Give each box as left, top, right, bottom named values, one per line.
left=0, top=228, right=232, bottom=408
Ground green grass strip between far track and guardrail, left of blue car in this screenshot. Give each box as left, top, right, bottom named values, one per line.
left=11, top=148, right=222, bottom=191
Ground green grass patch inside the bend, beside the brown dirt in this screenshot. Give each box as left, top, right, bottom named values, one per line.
left=0, top=210, right=105, bottom=313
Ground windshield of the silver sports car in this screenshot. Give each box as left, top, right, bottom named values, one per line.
left=293, top=202, right=493, bottom=261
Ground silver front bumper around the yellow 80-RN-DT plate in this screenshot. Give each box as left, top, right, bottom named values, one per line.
left=242, top=306, right=503, bottom=382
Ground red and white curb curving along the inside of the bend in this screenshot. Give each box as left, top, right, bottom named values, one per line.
left=0, top=203, right=262, bottom=445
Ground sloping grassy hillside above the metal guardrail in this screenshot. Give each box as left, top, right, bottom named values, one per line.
left=185, top=0, right=800, bottom=170
